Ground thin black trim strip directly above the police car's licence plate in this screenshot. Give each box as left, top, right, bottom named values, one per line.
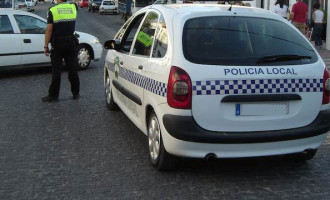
left=221, top=94, right=301, bottom=103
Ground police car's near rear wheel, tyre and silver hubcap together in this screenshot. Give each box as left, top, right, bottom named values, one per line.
left=148, top=111, right=178, bottom=171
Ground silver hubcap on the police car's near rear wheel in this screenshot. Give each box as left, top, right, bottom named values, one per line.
left=148, top=116, right=160, bottom=160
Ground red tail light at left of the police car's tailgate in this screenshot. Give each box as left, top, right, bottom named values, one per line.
left=167, top=66, right=192, bottom=109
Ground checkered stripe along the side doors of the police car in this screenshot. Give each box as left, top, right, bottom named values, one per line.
left=110, top=62, right=167, bottom=97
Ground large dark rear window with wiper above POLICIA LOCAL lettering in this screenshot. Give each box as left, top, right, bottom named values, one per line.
left=182, top=16, right=317, bottom=66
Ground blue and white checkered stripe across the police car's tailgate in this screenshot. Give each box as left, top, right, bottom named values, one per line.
left=192, top=79, right=323, bottom=95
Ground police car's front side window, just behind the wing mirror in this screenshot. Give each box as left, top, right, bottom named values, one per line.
left=118, top=14, right=144, bottom=53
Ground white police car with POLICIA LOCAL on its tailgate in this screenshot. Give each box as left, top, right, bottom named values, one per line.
left=104, top=4, right=330, bottom=170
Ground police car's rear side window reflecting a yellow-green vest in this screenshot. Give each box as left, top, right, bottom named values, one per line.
left=133, top=12, right=158, bottom=57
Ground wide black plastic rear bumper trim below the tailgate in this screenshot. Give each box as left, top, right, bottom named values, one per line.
left=163, top=110, right=330, bottom=144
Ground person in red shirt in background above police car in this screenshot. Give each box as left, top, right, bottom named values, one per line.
left=290, top=0, right=308, bottom=35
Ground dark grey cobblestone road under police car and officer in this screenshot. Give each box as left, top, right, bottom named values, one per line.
left=0, top=3, right=330, bottom=200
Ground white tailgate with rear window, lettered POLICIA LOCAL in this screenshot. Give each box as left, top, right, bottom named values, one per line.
left=183, top=16, right=324, bottom=131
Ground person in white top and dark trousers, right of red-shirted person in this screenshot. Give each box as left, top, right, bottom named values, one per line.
left=312, top=3, right=324, bottom=49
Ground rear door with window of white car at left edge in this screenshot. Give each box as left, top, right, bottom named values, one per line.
left=0, top=14, right=22, bottom=67
